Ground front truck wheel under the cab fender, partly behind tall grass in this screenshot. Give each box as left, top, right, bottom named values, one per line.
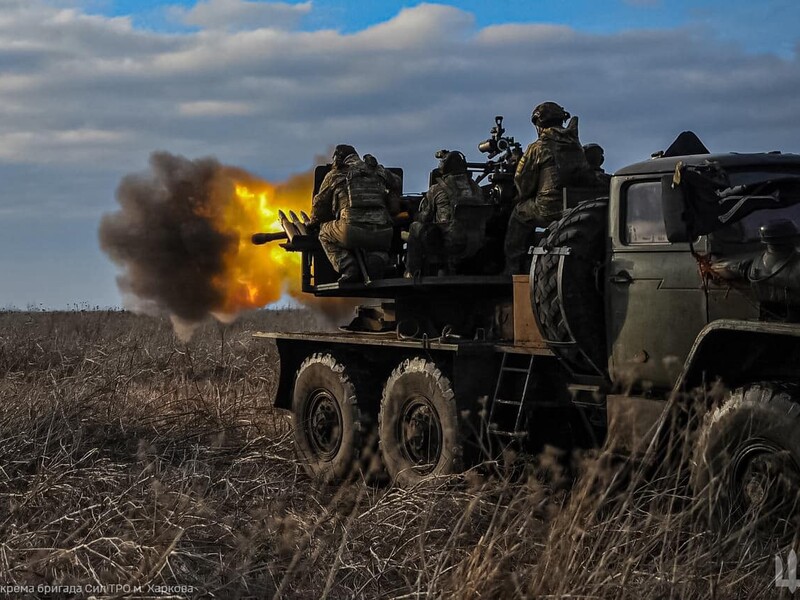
left=691, top=383, right=800, bottom=537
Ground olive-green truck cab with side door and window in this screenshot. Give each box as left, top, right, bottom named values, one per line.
left=605, top=154, right=800, bottom=394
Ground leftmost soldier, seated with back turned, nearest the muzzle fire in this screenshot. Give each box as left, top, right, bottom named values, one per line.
left=311, top=144, right=401, bottom=283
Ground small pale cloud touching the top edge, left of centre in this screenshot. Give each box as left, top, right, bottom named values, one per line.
left=171, top=0, right=311, bottom=30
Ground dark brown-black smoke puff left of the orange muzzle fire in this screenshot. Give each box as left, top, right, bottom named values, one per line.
left=99, top=152, right=238, bottom=333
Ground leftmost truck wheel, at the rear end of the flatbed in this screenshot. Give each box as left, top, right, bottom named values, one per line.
left=292, top=354, right=361, bottom=482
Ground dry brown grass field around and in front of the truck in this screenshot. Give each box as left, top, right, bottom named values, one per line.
left=0, top=311, right=788, bottom=600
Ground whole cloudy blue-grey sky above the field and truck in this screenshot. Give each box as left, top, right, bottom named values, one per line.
left=0, top=0, right=800, bottom=308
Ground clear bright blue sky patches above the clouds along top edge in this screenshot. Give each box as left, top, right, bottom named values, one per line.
left=95, top=0, right=800, bottom=56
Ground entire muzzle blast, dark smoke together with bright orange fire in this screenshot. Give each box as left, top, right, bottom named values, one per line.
left=99, top=152, right=355, bottom=340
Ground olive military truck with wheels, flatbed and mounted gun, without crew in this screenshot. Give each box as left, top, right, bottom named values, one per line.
left=256, top=124, right=800, bottom=528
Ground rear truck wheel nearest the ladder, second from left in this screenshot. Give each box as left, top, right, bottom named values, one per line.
left=378, top=358, right=463, bottom=487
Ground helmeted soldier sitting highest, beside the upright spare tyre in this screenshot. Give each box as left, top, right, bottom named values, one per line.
left=505, top=102, right=597, bottom=274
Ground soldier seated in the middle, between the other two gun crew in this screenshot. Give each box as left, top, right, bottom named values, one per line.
left=405, top=150, right=486, bottom=277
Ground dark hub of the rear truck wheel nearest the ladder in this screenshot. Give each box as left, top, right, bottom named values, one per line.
left=398, top=396, right=442, bottom=475
